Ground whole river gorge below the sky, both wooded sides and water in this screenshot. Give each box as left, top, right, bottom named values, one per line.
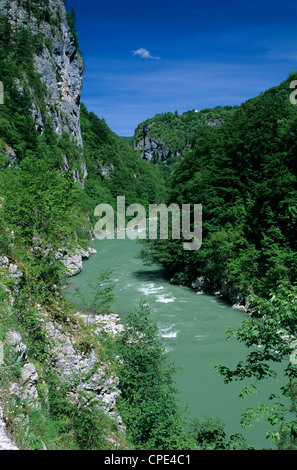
left=0, top=0, right=297, bottom=451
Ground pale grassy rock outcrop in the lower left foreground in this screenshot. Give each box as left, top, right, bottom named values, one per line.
left=0, top=252, right=125, bottom=450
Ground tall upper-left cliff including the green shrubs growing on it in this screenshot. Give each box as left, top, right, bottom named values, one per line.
left=0, top=0, right=86, bottom=179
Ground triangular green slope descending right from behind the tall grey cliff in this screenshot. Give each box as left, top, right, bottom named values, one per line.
left=81, top=105, right=164, bottom=220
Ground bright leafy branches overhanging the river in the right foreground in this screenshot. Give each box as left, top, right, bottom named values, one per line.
left=217, top=285, right=297, bottom=449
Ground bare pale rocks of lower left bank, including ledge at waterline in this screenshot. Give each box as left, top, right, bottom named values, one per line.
left=0, top=247, right=125, bottom=450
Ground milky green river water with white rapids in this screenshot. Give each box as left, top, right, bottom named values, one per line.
left=67, top=234, right=277, bottom=449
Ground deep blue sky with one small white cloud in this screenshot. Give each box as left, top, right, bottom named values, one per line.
left=67, top=0, right=297, bottom=136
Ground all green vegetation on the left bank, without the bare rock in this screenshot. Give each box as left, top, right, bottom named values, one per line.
left=0, top=2, right=204, bottom=450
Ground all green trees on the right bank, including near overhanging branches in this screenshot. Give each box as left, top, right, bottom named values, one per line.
left=137, top=72, right=297, bottom=449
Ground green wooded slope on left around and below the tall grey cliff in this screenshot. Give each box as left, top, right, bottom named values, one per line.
left=0, top=8, right=163, bottom=298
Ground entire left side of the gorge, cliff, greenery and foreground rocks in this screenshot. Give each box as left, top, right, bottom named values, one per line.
left=0, top=0, right=164, bottom=449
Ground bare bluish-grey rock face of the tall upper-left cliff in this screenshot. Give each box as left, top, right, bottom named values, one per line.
left=0, top=0, right=84, bottom=149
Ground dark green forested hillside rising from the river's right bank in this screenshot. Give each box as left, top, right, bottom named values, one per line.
left=140, top=73, right=297, bottom=302
